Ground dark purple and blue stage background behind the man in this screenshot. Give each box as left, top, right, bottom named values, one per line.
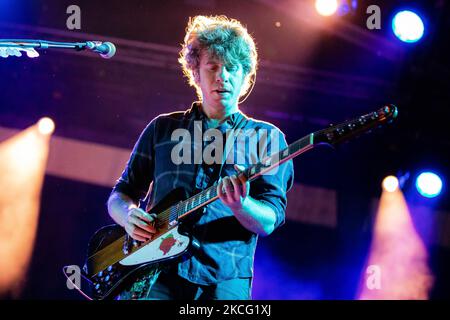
left=0, top=0, right=450, bottom=299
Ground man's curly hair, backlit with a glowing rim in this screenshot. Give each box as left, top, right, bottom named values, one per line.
left=178, top=15, right=258, bottom=100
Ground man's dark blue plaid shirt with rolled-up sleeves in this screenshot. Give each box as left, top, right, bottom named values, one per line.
left=113, top=103, right=293, bottom=285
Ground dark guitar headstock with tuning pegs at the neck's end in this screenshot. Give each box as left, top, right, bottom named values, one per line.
left=314, top=104, right=398, bottom=145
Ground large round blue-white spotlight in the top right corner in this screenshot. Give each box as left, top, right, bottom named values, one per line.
left=392, top=10, right=425, bottom=42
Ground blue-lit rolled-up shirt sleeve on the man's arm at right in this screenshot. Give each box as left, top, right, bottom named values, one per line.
left=250, top=127, right=294, bottom=228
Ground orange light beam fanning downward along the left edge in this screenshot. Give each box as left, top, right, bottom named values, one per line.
left=0, top=122, right=50, bottom=298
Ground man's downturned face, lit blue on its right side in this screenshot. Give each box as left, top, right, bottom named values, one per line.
left=196, top=51, right=244, bottom=110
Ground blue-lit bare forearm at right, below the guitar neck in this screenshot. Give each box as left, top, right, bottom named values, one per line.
left=231, top=196, right=277, bottom=236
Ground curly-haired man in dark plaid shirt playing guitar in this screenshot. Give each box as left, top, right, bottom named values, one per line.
left=108, top=16, right=293, bottom=300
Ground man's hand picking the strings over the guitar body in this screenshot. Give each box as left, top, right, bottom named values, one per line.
left=124, top=208, right=156, bottom=241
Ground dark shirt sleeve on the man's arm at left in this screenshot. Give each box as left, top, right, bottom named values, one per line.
left=112, top=119, right=156, bottom=202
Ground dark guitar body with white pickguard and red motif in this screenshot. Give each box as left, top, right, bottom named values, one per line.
left=83, top=189, right=191, bottom=300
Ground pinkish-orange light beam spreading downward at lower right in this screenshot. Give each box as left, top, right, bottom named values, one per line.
left=358, top=179, right=434, bottom=300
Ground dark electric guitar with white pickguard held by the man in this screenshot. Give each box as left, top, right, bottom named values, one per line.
left=67, top=104, right=398, bottom=300
